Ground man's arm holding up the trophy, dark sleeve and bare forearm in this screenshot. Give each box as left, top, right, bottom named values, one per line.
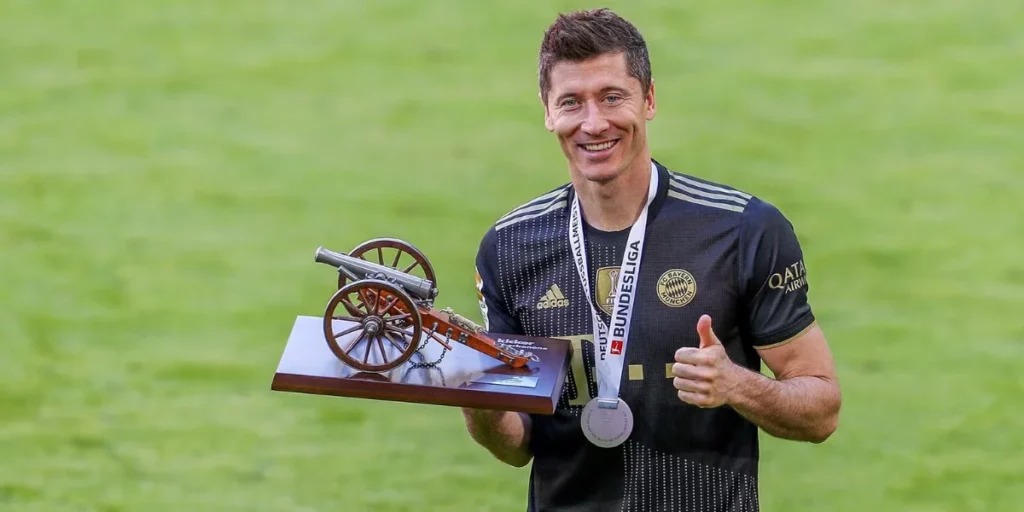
left=462, top=228, right=532, bottom=467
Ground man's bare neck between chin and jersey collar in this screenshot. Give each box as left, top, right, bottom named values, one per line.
left=572, top=158, right=651, bottom=231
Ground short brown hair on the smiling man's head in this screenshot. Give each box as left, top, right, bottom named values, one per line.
left=538, top=8, right=651, bottom=102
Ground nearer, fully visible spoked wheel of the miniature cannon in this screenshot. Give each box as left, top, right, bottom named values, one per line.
left=324, top=280, right=422, bottom=372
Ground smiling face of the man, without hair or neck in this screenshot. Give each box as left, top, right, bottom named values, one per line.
left=544, top=53, right=655, bottom=182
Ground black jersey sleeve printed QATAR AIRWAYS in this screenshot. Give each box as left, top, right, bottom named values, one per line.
left=740, top=198, right=814, bottom=348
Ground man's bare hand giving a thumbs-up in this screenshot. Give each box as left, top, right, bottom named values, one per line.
left=672, top=314, right=739, bottom=408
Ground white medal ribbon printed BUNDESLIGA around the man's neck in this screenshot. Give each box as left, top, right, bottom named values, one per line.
left=569, top=162, right=657, bottom=408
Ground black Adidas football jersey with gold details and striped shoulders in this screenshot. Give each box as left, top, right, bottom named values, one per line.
left=476, top=157, right=814, bottom=512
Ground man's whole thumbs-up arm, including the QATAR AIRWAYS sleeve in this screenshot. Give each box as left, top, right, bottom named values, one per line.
left=673, top=200, right=842, bottom=442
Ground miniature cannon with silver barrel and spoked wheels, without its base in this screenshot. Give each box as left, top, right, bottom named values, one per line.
left=314, top=239, right=538, bottom=372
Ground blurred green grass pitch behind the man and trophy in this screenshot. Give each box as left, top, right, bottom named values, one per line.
left=0, top=0, right=1024, bottom=512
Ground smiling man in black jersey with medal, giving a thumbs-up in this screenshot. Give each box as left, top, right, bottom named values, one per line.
left=464, top=9, right=841, bottom=512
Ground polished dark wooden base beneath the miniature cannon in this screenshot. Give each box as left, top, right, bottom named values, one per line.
left=270, top=315, right=571, bottom=415
